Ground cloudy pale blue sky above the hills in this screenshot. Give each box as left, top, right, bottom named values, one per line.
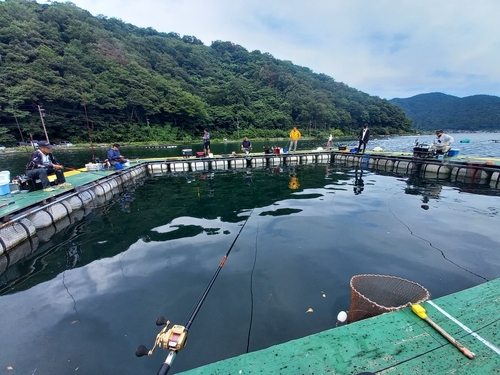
left=45, top=0, right=500, bottom=99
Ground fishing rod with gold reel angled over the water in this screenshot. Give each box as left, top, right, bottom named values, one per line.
left=135, top=210, right=253, bottom=375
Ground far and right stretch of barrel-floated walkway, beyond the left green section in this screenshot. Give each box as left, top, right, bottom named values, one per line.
left=141, top=150, right=500, bottom=189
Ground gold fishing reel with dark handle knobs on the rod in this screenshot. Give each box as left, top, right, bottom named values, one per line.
left=135, top=316, right=188, bottom=357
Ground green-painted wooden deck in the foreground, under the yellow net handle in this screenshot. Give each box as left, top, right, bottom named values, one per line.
left=178, top=279, right=500, bottom=375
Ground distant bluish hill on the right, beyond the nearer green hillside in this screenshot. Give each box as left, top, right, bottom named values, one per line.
left=390, top=93, right=500, bottom=131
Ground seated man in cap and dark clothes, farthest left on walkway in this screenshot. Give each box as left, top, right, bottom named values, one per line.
left=26, top=141, right=72, bottom=191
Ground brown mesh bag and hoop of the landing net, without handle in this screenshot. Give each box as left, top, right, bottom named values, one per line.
left=348, top=275, right=430, bottom=323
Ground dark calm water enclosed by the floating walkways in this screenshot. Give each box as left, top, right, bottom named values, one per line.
left=0, top=137, right=500, bottom=375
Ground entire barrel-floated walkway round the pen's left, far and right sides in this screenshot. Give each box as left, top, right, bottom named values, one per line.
left=0, top=150, right=500, bottom=266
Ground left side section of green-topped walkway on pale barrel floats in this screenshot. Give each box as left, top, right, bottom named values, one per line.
left=0, top=164, right=146, bottom=274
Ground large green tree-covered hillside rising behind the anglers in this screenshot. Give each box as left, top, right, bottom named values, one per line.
left=0, top=0, right=412, bottom=143
